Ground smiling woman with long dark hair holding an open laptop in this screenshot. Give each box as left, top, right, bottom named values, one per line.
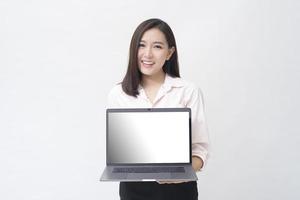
left=108, top=19, right=208, bottom=200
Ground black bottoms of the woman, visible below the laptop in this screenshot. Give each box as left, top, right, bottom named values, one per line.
left=119, top=181, right=198, bottom=200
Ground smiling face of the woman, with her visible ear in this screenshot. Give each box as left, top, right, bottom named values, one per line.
left=138, top=28, right=175, bottom=76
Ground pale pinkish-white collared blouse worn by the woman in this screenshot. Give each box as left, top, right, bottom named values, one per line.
left=107, top=74, right=209, bottom=167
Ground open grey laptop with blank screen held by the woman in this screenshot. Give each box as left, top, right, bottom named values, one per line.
left=100, top=108, right=198, bottom=181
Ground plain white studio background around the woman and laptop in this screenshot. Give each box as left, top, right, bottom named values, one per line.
left=0, top=0, right=300, bottom=200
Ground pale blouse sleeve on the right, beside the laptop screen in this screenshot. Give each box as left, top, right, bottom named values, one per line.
left=187, top=88, right=209, bottom=167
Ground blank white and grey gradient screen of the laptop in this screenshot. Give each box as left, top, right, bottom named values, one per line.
left=107, top=108, right=190, bottom=164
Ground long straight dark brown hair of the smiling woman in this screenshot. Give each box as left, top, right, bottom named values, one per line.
left=122, top=18, right=180, bottom=97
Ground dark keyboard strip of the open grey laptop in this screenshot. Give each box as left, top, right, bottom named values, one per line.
left=113, top=167, right=185, bottom=173
